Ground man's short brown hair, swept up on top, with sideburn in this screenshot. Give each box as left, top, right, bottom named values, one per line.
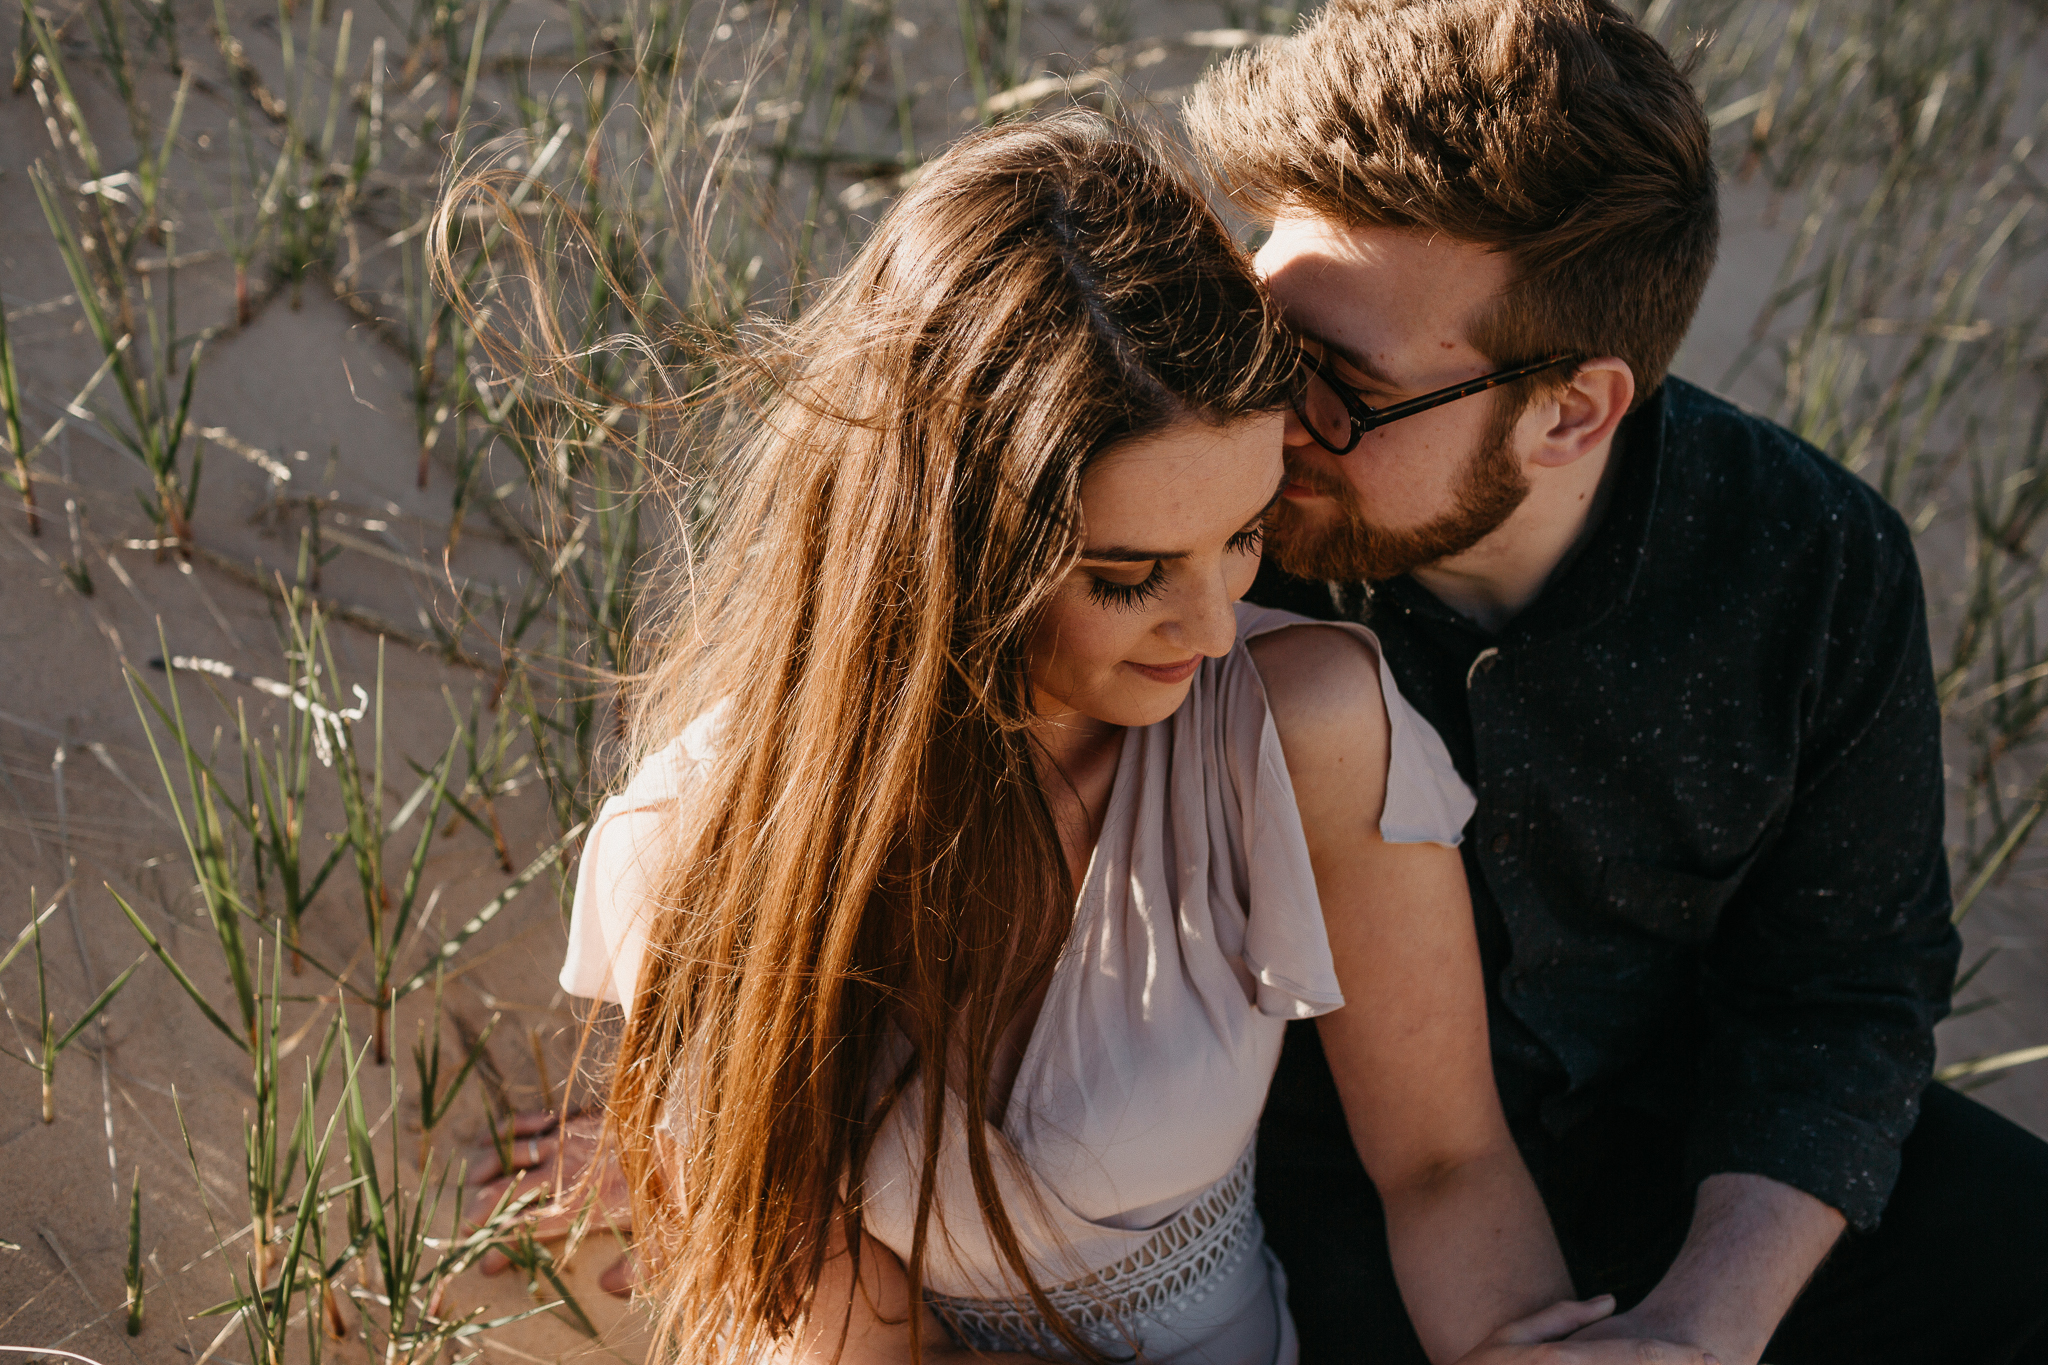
left=1186, top=0, right=1720, bottom=407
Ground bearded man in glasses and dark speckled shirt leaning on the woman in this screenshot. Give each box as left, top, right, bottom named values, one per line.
left=1188, top=0, right=2048, bottom=1365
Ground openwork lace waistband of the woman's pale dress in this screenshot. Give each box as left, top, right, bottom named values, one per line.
left=926, top=1146, right=1262, bottom=1355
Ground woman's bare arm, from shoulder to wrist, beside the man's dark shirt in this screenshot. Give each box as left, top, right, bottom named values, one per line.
left=1251, top=628, right=1571, bottom=1361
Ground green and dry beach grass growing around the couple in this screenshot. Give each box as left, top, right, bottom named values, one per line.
left=0, top=0, right=2048, bottom=1365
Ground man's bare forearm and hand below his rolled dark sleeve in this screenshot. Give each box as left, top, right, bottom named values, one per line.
left=1571, top=1175, right=1843, bottom=1365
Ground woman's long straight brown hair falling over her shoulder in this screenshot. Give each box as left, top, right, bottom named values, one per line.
left=608, top=113, right=1292, bottom=1365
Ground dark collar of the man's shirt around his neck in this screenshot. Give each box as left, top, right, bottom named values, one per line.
left=1374, top=385, right=1671, bottom=641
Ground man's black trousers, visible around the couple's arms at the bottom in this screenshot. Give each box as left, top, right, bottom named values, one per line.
left=1257, top=1023, right=2048, bottom=1365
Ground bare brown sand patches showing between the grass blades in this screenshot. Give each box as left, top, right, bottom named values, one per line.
left=0, top=0, right=2048, bottom=1365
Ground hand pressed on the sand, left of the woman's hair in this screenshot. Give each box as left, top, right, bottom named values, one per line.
left=465, top=1111, right=633, bottom=1295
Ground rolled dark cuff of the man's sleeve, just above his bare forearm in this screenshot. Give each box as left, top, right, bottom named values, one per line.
left=1686, top=1095, right=1919, bottom=1232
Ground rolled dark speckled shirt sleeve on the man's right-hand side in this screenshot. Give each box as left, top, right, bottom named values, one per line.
left=1688, top=507, right=1960, bottom=1230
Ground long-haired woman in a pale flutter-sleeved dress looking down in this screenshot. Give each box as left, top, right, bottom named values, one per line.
left=503, top=115, right=1700, bottom=1365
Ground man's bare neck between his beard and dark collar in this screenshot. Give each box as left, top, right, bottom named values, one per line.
left=1413, top=434, right=1620, bottom=634
